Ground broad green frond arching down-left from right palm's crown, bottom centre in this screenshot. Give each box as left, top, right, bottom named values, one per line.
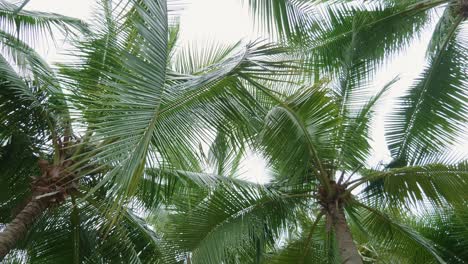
left=166, top=184, right=304, bottom=263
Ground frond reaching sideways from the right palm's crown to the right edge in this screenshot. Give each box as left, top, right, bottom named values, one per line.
left=350, top=162, right=468, bottom=207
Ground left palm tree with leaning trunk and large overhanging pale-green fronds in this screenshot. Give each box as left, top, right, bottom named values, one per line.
left=0, top=0, right=287, bottom=263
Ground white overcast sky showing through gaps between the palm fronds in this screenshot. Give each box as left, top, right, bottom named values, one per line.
left=16, top=0, right=468, bottom=181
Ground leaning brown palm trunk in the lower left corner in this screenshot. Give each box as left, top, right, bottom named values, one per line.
left=0, top=198, right=50, bottom=261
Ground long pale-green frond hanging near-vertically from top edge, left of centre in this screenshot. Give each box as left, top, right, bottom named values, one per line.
left=70, top=1, right=167, bottom=205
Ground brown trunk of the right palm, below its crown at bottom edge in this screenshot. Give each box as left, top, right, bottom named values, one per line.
left=330, top=205, right=362, bottom=264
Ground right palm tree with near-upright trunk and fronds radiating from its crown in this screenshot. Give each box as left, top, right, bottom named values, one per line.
left=158, top=76, right=468, bottom=263
